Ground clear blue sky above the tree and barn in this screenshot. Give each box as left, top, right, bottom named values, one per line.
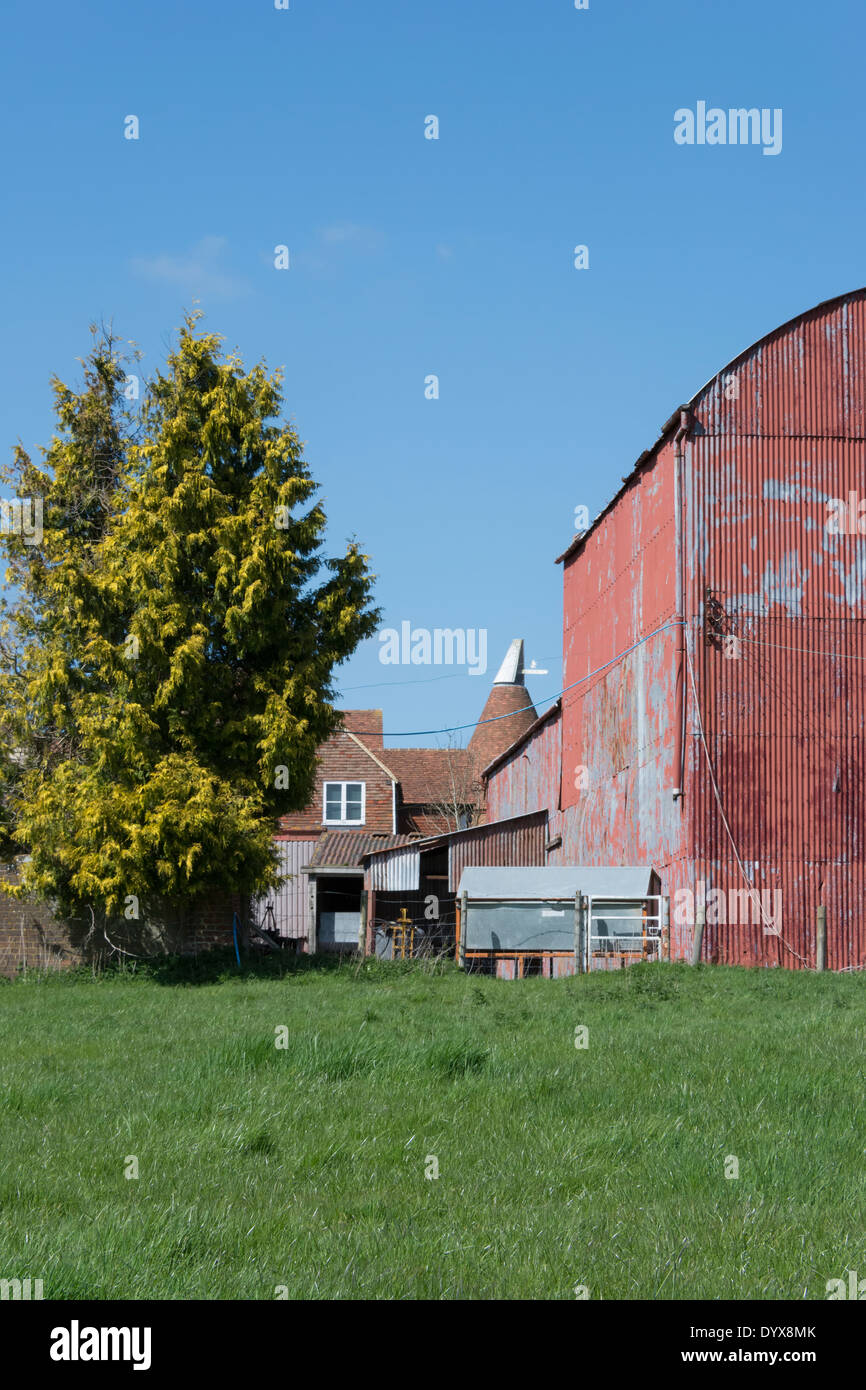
left=0, top=0, right=866, bottom=745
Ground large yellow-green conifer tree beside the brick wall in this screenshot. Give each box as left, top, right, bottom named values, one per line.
left=0, top=316, right=378, bottom=915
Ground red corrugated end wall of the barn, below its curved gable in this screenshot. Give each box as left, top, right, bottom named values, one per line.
left=688, top=422, right=866, bottom=969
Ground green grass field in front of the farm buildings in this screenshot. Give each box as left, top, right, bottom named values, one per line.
left=0, top=960, right=866, bottom=1300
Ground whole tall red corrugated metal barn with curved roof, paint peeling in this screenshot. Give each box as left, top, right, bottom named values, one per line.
left=488, top=291, right=866, bottom=969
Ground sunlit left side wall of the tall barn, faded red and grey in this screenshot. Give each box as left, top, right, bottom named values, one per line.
left=561, top=442, right=688, bottom=877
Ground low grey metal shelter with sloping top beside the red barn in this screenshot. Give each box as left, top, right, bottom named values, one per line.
left=457, top=865, right=666, bottom=979
